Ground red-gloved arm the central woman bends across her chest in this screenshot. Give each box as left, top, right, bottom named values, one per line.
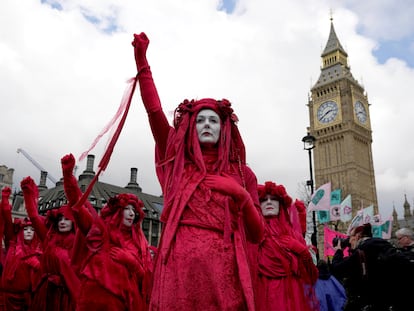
left=204, top=174, right=263, bottom=242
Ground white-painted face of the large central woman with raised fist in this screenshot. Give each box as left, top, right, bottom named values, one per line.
left=196, top=109, right=221, bottom=145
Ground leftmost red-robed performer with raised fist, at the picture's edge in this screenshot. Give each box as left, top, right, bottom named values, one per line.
left=1, top=187, right=42, bottom=311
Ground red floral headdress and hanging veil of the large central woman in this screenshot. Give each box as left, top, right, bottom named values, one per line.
left=160, top=98, right=246, bottom=221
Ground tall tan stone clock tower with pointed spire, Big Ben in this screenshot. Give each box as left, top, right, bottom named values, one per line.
left=308, top=19, right=378, bottom=215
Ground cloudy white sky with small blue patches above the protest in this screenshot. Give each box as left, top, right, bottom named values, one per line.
left=0, top=0, right=414, bottom=217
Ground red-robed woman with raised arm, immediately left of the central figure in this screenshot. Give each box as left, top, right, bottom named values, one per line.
left=61, top=154, right=151, bottom=311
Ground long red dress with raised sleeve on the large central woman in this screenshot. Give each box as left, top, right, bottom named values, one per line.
left=138, top=45, right=260, bottom=311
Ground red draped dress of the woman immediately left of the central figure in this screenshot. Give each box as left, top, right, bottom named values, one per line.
left=74, top=202, right=149, bottom=311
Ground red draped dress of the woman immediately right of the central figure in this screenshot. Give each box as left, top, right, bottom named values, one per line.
left=257, top=214, right=319, bottom=311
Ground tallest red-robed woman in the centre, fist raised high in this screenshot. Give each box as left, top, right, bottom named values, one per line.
left=133, top=33, right=263, bottom=311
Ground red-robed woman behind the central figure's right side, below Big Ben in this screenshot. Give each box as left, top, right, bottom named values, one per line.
left=257, top=181, right=319, bottom=311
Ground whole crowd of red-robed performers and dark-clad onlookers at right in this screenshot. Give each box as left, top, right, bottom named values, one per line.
left=0, top=33, right=414, bottom=311
